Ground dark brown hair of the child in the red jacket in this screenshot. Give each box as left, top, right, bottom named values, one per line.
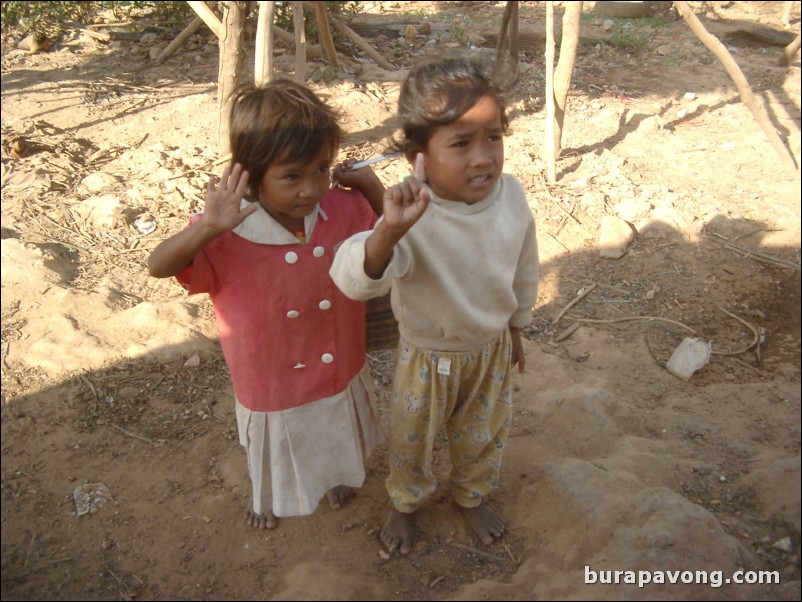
left=229, top=79, right=343, bottom=199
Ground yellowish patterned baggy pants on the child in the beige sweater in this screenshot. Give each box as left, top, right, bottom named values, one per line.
left=385, top=329, right=512, bottom=513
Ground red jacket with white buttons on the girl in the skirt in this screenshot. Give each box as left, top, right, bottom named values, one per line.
left=177, top=189, right=376, bottom=412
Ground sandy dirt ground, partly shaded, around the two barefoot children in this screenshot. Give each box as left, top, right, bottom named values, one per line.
left=2, top=2, right=800, bottom=600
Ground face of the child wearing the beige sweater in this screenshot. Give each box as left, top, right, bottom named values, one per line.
left=424, top=96, right=504, bottom=205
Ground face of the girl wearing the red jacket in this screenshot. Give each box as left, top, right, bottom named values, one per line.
left=259, top=145, right=331, bottom=230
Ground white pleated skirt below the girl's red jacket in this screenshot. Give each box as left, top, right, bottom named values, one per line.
left=235, top=362, right=385, bottom=516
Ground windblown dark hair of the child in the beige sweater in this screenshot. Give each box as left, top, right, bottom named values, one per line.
left=391, top=55, right=509, bottom=152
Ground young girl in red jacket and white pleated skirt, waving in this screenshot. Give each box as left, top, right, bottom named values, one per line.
left=148, top=80, right=384, bottom=529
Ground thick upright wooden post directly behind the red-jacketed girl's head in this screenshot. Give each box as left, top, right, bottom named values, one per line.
left=217, top=2, right=248, bottom=156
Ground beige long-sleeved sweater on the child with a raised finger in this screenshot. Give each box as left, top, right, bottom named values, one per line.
left=330, top=174, right=538, bottom=351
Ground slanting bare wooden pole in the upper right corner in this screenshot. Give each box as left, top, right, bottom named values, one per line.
left=674, top=1, right=799, bottom=174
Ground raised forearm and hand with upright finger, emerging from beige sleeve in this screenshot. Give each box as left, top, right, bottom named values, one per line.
left=365, top=153, right=430, bottom=280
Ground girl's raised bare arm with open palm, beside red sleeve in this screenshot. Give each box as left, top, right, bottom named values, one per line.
left=148, top=164, right=257, bottom=278
